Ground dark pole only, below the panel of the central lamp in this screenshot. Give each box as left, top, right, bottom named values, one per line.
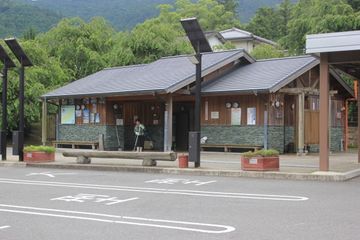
left=194, top=51, right=202, bottom=168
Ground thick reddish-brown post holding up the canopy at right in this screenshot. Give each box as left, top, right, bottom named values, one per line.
left=319, top=53, right=329, bottom=171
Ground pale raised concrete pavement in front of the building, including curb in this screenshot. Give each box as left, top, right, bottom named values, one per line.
left=0, top=148, right=360, bottom=181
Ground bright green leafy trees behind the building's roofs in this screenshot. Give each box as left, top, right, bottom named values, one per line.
left=0, top=0, right=360, bottom=130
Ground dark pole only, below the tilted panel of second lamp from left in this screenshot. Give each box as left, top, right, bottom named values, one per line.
left=19, top=63, right=25, bottom=162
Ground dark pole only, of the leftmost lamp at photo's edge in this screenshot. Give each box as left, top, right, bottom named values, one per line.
left=1, top=64, right=8, bottom=161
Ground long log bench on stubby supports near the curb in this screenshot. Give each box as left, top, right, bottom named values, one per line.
left=63, top=151, right=176, bottom=166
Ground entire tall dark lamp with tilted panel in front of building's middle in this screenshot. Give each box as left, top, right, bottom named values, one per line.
left=180, top=18, right=212, bottom=168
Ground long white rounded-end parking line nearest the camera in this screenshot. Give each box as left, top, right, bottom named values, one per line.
left=0, top=204, right=235, bottom=234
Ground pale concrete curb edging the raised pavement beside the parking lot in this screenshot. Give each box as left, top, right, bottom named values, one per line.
left=23, top=163, right=360, bottom=182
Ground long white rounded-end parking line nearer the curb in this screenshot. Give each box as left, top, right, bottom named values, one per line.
left=0, top=178, right=309, bottom=201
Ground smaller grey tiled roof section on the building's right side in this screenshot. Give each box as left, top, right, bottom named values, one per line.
left=202, top=56, right=319, bottom=94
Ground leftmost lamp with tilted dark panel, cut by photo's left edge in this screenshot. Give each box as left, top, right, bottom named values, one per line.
left=0, top=45, right=16, bottom=161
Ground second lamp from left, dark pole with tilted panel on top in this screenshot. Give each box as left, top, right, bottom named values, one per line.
left=5, top=38, right=33, bottom=162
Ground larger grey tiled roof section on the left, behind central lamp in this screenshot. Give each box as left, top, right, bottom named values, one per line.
left=42, top=49, right=254, bottom=98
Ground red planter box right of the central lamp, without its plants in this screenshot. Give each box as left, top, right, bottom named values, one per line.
left=241, top=157, right=279, bottom=171
